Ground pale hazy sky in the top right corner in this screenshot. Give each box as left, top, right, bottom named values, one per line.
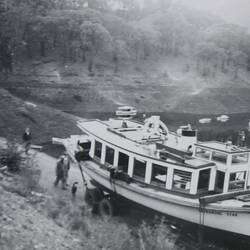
left=178, top=0, right=250, bottom=30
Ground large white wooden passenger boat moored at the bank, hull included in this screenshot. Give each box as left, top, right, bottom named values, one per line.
left=55, top=116, right=250, bottom=236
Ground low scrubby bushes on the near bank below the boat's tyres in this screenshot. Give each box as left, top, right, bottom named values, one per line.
left=43, top=197, right=184, bottom=250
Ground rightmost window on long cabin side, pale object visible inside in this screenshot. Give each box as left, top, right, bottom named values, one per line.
left=173, top=169, right=192, bottom=191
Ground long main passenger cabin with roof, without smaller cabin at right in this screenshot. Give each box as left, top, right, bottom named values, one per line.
left=78, top=120, right=216, bottom=197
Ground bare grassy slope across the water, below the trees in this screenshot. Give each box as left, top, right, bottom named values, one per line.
left=5, top=58, right=250, bottom=115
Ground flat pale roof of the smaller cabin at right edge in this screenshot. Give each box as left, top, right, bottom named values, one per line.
left=195, top=141, right=250, bottom=154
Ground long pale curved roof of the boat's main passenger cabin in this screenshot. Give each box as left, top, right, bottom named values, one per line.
left=78, top=120, right=214, bottom=169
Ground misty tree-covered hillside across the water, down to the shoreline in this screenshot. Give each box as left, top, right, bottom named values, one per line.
left=0, top=0, right=250, bottom=114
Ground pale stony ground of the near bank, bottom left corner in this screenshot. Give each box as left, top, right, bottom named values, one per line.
left=0, top=184, right=83, bottom=250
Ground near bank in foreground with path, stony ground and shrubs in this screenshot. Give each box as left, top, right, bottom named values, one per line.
left=0, top=142, right=188, bottom=250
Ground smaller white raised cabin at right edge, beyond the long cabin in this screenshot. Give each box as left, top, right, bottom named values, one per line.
left=193, top=141, right=250, bottom=193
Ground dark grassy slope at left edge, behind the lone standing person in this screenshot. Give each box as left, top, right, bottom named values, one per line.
left=0, top=88, right=80, bottom=143
